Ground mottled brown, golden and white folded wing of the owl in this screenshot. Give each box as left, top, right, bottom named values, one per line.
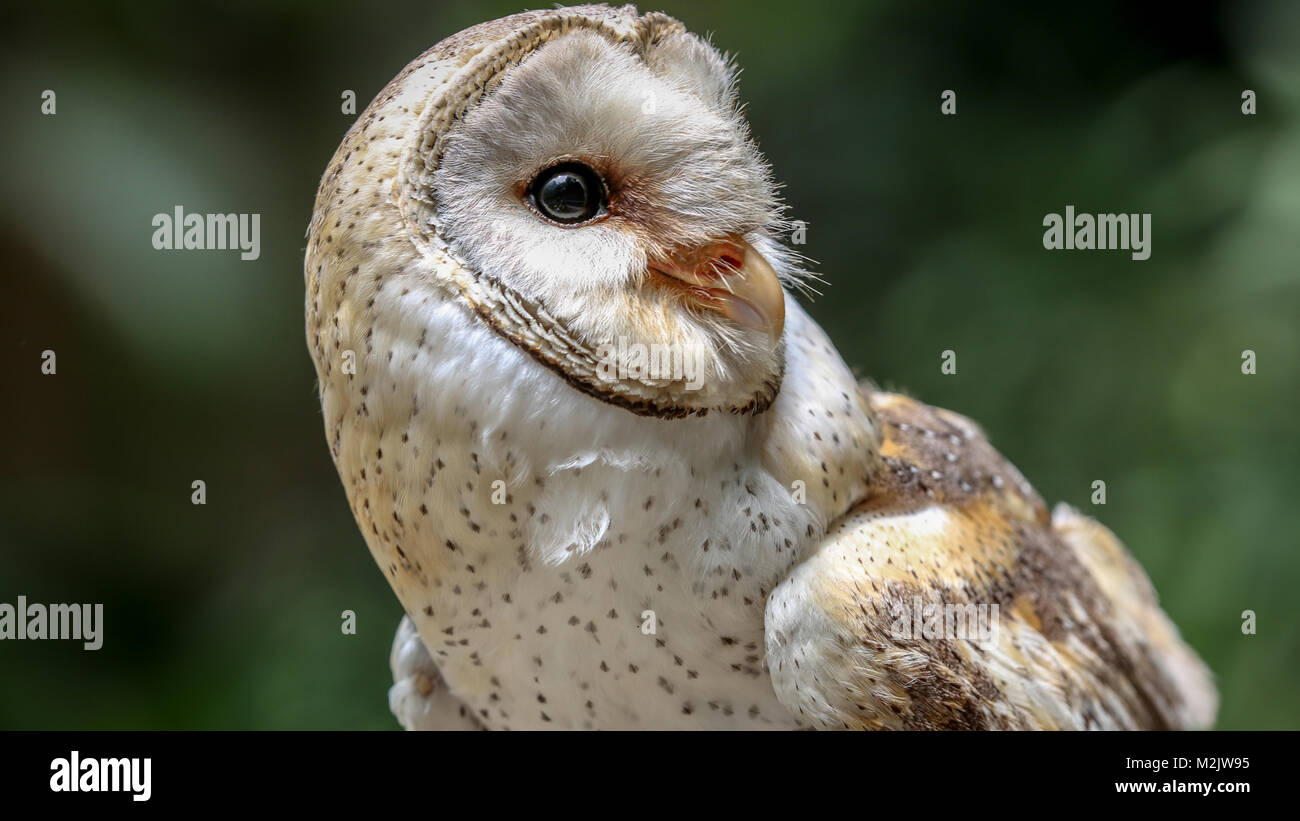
left=764, top=392, right=1217, bottom=729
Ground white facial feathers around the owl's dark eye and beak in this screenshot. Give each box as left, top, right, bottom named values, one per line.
left=434, top=31, right=800, bottom=405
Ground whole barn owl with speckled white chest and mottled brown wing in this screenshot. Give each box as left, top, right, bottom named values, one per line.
left=304, top=5, right=1217, bottom=729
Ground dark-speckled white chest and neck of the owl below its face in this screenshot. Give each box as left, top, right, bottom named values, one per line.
left=324, top=280, right=875, bottom=729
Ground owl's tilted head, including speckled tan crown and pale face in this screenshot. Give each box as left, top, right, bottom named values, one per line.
left=307, top=5, right=802, bottom=418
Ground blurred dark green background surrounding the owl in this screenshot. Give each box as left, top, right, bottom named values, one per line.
left=0, top=0, right=1300, bottom=729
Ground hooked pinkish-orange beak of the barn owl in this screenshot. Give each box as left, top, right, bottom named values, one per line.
left=650, top=242, right=785, bottom=343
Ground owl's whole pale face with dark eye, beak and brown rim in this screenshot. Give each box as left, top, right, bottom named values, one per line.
left=421, top=18, right=800, bottom=416
